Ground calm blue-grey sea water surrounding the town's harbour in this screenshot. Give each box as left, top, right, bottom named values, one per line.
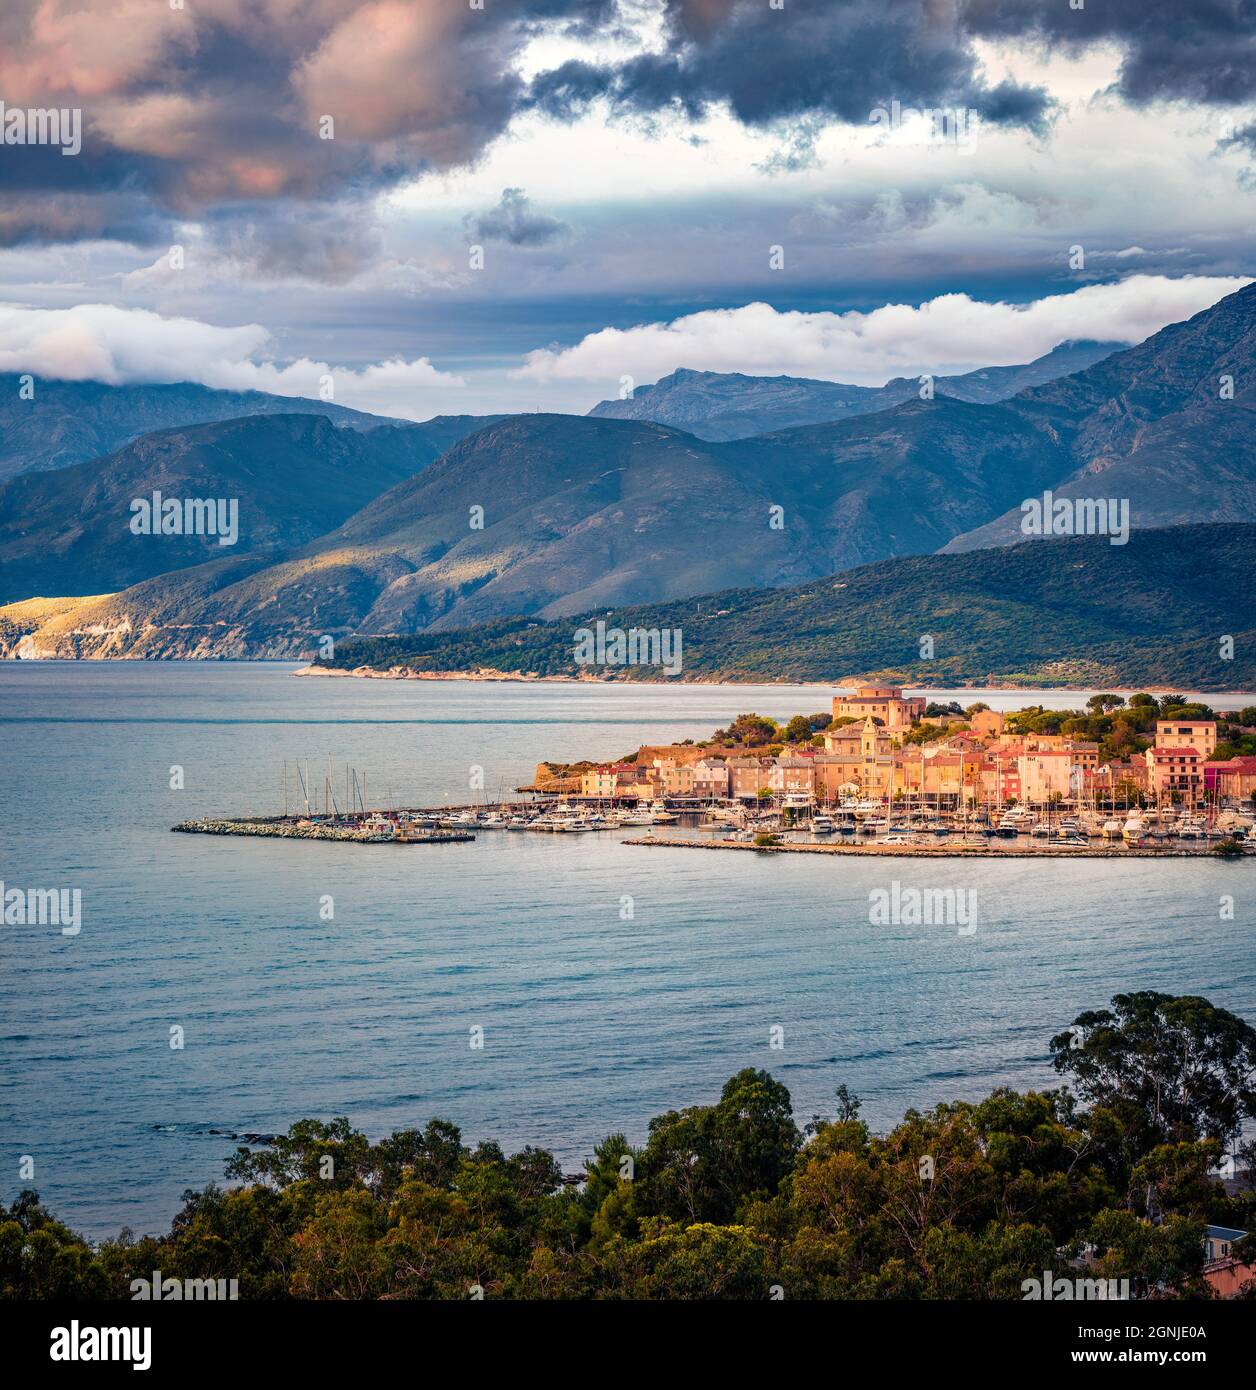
left=0, top=663, right=1256, bottom=1236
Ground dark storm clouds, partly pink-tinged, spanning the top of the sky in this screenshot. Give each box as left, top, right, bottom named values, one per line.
left=0, top=0, right=1256, bottom=264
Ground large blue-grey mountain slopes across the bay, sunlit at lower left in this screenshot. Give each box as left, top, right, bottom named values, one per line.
left=0, top=285, right=1256, bottom=656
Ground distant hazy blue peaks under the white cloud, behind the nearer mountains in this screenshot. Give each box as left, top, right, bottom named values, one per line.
left=589, top=342, right=1120, bottom=441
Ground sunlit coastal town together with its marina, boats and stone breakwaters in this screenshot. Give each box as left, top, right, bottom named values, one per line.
left=175, top=684, right=1256, bottom=856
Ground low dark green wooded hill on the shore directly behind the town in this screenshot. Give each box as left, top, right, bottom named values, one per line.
left=304, top=525, right=1256, bottom=689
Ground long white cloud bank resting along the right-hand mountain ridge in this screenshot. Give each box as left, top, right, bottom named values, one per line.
left=514, top=275, right=1249, bottom=385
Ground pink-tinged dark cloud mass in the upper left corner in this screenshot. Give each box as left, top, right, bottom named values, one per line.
left=0, top=0, right=615, bottom=239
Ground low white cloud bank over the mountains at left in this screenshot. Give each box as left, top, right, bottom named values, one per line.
left=0, top=304, right=464, bottom=420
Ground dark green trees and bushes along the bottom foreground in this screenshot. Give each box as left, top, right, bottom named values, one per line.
left=9, top=992, right=1256, bottom=1300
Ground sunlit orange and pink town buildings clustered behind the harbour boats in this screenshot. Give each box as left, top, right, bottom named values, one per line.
left=555, top=685, right=1256, bottom=833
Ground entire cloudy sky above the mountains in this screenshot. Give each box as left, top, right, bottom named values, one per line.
left=0, top=0, right=1256, bottom=420
